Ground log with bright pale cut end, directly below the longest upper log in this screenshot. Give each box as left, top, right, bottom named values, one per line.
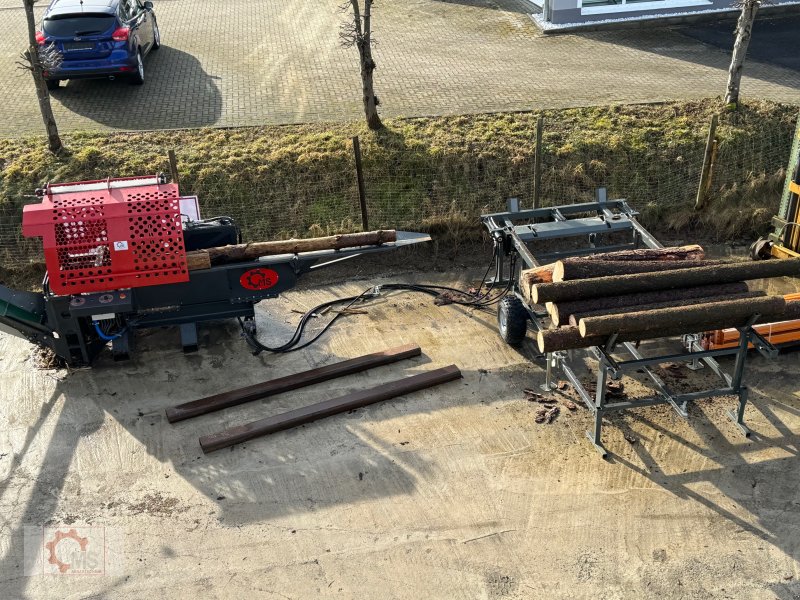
left=547, top=282, right=748, bottom=327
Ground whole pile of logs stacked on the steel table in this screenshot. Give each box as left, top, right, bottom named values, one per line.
left=520, top=245, right=800, bottom=352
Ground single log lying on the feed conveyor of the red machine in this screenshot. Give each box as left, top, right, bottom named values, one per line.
left=186, top=229, right=397, bottom=271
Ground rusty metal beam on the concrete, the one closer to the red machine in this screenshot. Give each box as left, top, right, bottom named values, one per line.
left=167, top=344, right=422, bottom=423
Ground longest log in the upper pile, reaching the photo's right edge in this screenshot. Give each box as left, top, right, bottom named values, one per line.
left=531, top=258, right=800, bottom=304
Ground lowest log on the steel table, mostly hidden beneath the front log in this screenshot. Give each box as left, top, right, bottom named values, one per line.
left=536, top=301, right=800, bottom=354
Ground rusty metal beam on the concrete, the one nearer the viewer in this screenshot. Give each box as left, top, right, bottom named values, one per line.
left=200, top=365, right=461, bottom=454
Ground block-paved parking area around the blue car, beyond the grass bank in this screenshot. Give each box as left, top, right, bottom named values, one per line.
left=0, top=0, right=800, bottom=137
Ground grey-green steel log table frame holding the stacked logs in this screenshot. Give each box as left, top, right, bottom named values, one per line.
left=481, top=189, right=778, bottom=457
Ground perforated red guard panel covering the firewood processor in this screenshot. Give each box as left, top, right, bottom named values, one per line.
left=22, top=179, right=189, bottom=294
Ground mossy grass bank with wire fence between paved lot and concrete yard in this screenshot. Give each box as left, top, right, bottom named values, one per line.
left=0, top=107, right=796, bottom=266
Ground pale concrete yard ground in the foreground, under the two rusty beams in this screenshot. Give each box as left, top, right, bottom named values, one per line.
left=0, top=258, right=800, bottom=600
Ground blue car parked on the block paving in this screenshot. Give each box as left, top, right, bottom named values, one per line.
left=36, top=0, right=161, bottom=90
